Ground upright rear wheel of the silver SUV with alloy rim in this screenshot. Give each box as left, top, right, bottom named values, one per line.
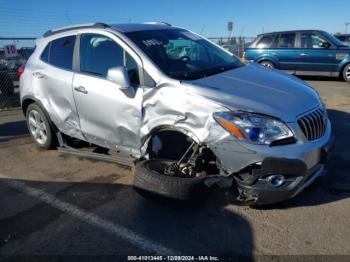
left=26, top=103, right=56, bottom=149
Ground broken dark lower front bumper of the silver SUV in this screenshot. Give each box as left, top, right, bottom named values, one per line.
left=235, top=136, right=335, bottom=205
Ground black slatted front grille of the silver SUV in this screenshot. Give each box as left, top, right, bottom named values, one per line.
left=298, top=108, right=327, bottom=141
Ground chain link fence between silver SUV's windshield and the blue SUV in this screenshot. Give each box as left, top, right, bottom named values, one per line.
left=208, top=36, right=255, bottom=58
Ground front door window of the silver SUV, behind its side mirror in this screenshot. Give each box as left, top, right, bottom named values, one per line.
left=80, top=34, right=139, bottom=85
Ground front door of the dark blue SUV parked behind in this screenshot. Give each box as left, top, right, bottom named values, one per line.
left=296, top=31, right=339, bottom=75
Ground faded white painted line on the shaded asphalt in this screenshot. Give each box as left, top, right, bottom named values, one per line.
left=0, top=178, right=180, bottom=255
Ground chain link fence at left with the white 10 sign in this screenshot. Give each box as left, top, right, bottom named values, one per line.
left=0, top=37, right=35, bottom=110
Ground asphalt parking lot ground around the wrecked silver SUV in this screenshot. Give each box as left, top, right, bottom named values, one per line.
left=0, top=79, right=350, bottom=259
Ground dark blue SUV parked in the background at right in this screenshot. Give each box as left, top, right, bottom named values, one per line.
left=245, top=30, right=350, bottom=82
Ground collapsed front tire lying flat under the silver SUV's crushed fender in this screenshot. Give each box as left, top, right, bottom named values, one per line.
left=134, top=159, right=208, bottom=200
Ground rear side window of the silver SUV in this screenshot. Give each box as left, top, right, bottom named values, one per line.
left=48, top=36, right=75, bottom=70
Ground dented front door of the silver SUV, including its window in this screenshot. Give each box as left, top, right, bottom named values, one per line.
left=73, top=34, right=143, bottom=156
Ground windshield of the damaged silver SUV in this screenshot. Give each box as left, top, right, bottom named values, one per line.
left=127, top=29, right=242, bottom=80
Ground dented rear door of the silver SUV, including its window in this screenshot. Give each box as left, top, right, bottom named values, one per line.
left=36, top=35, right=82, bottom=138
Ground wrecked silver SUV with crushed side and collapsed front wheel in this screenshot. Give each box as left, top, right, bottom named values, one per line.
left=20, top=23, right=333, bottom=205
